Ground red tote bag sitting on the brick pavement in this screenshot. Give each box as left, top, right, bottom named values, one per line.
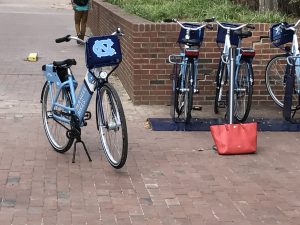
left=210, top=123, right=257, bottom=155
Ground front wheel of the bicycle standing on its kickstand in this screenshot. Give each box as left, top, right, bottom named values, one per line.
left=96, top=83, right=128, bottom=169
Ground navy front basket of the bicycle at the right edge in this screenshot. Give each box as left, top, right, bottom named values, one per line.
left=269, top=22, right=294, bottom=47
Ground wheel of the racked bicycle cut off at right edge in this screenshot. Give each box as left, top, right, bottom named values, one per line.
left=265, top=54, right=298, bottom=110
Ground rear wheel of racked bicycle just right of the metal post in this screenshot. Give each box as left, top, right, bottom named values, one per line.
left=234, top=61, right=253, bottom=122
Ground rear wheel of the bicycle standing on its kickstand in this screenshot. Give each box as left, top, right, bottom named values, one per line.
left=42, top=82, right=74, bottom=153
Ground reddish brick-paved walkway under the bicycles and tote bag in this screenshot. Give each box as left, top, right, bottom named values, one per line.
left=0, top=0, right=300, bottom=225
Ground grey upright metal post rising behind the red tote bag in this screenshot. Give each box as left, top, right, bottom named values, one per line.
left=228, top=47, right=236, bottom=124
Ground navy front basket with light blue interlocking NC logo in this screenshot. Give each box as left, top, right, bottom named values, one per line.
left=85, top=35, right=122, bottom=69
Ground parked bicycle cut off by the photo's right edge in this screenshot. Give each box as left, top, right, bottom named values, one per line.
left=265, top=20, right=300, bottom=119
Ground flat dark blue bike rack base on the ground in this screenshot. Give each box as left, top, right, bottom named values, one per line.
left=148, top=118, right=300, bottom=132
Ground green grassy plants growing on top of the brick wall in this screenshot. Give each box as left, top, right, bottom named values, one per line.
left=105, top=0, right=288, bottom=23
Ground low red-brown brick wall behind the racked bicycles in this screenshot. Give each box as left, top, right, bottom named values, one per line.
left=88, top=0, right=279, bottom=105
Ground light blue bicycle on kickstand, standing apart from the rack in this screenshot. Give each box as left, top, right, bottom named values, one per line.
left=41, top=29, right=128, bottom=169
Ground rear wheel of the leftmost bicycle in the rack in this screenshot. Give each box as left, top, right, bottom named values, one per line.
left=184, top=62, right=194, bottom=123
